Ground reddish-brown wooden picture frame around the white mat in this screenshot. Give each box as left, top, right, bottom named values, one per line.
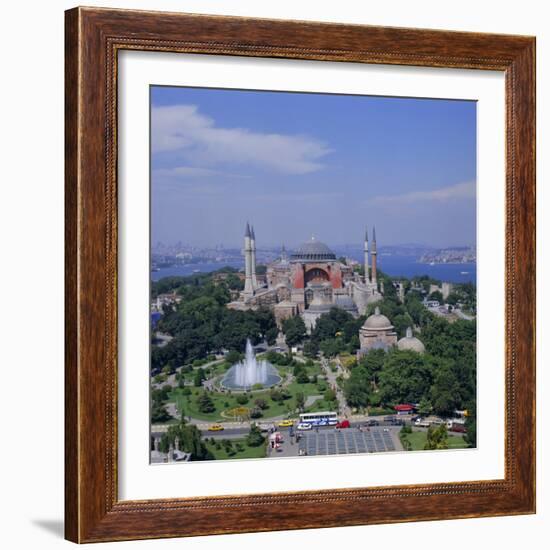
left=65, top=8, right=535, bottom=543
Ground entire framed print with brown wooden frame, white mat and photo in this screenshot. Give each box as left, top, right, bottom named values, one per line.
left=66, top=8, right=535, bottom=542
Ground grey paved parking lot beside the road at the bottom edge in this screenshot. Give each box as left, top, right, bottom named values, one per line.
left=296, top=428, right=403, bottom=456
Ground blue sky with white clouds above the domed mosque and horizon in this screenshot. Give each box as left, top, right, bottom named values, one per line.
left=151, top=86, right=476, bottom=246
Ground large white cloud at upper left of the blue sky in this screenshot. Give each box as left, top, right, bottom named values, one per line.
left=152, top=105, right=330, bottom=174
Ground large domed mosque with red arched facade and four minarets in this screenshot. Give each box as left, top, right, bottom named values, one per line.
left=228, top=224, right=382, bottom=331
